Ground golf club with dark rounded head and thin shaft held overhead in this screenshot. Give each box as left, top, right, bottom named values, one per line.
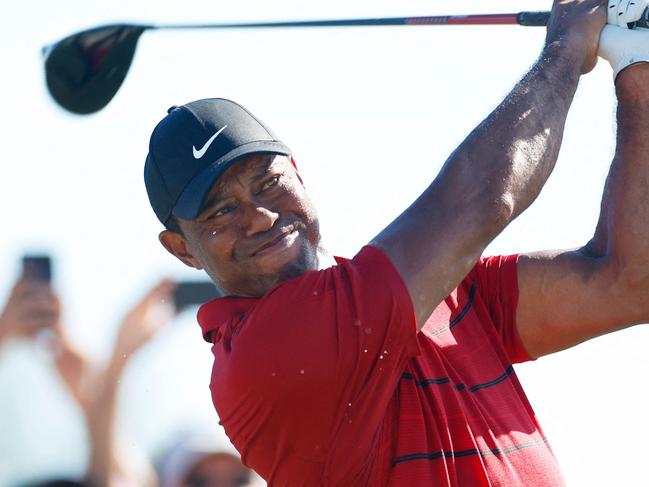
left=43, top=10, right=649, bottom=114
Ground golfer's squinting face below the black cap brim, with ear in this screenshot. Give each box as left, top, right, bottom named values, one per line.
left=161, top=154, right=320, bottom=296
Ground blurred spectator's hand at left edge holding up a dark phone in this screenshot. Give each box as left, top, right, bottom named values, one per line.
left=0, top=279, right=61, bottom=346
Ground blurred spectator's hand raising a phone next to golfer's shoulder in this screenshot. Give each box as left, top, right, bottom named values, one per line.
left=113, top=281, right=175, bottom=359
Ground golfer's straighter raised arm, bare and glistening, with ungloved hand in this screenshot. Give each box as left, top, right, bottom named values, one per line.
left=372, top=0, right=607, bottom=327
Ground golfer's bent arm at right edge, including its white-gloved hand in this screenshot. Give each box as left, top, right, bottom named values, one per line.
left=516, top=32, right=649, bottom=357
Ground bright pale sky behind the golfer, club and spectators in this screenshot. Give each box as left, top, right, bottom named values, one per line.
left=0, top=0, right=649, bottom=486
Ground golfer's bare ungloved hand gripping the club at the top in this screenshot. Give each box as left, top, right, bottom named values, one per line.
left=545, top=0, right=608, bottom=74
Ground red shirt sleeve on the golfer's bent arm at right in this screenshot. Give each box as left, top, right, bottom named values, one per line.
left=470, top=254, right=533, bottom=363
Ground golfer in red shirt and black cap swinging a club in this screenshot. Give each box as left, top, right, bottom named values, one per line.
left=145, top=0, right=649, bottom=487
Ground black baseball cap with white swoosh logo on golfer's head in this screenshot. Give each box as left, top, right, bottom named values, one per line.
left=144, top=98, right=291, bottom=224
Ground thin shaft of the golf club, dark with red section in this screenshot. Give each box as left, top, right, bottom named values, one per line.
left=152, top=12, right=550, bottom=29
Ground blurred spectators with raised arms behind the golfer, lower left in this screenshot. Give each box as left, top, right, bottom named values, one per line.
left=0, top=262, right=263, bottom=487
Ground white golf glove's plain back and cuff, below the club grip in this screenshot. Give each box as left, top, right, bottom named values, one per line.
left=597, top=25, right=649, bottom=80
